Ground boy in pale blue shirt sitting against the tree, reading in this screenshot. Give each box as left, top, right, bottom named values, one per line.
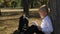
left=23, top=5, right=53, bottom=34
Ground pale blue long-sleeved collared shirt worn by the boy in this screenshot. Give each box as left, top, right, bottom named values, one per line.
left=40, top=16, right=53, bottom=34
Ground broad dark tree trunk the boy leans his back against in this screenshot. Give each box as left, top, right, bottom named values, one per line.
left=50, top=0, right=60, bottom=34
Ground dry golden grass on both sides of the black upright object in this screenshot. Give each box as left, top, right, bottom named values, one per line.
left=0, top=18, right=40, bottom=34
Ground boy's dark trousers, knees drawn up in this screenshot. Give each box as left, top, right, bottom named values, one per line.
left=24, top=25, right=44, bottom=34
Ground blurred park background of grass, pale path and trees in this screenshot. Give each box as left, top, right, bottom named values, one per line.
left=0, top=0, right=50, bottom=34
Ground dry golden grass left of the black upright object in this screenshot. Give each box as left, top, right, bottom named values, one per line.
left=0, top=19, right=18, bottom=34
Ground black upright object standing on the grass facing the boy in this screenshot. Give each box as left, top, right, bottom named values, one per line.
left=18, top=15, right=28, bottom=33
